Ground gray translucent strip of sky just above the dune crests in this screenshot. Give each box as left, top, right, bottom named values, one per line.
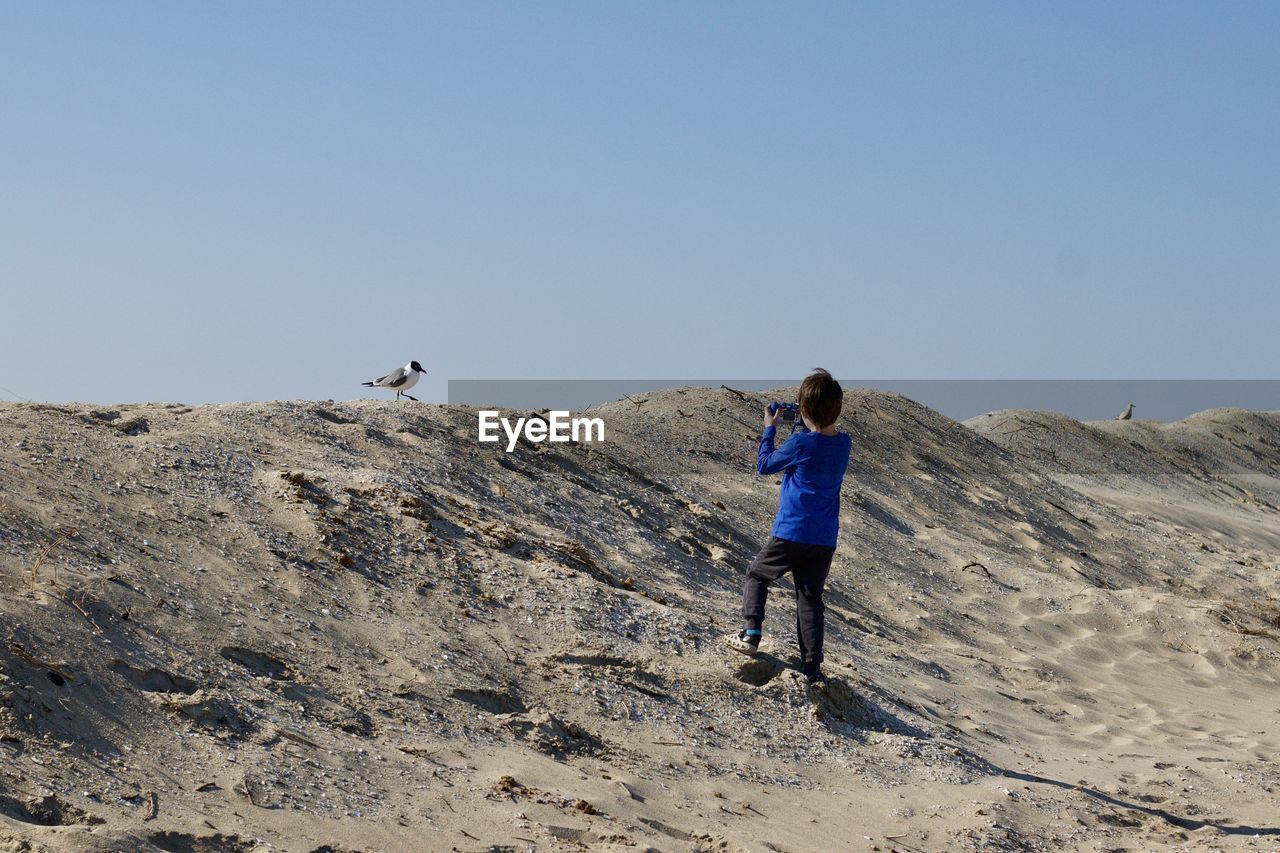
left=448, top=378, right=1280, bottom=421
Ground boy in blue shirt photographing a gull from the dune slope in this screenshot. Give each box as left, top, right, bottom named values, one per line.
left=728, top=368, right=852, bottom=684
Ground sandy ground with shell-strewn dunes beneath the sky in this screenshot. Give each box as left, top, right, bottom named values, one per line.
left=0, top=389, right=1280, bottom=852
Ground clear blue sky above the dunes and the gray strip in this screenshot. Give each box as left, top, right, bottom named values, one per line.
left=0, top=0, right=1280, bottom=402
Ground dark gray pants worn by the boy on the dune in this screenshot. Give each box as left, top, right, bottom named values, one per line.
left=742, top=537, right=836, bottom=663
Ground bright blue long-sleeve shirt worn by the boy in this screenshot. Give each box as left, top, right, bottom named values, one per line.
left=755, top=427, right=854, bottom=546
